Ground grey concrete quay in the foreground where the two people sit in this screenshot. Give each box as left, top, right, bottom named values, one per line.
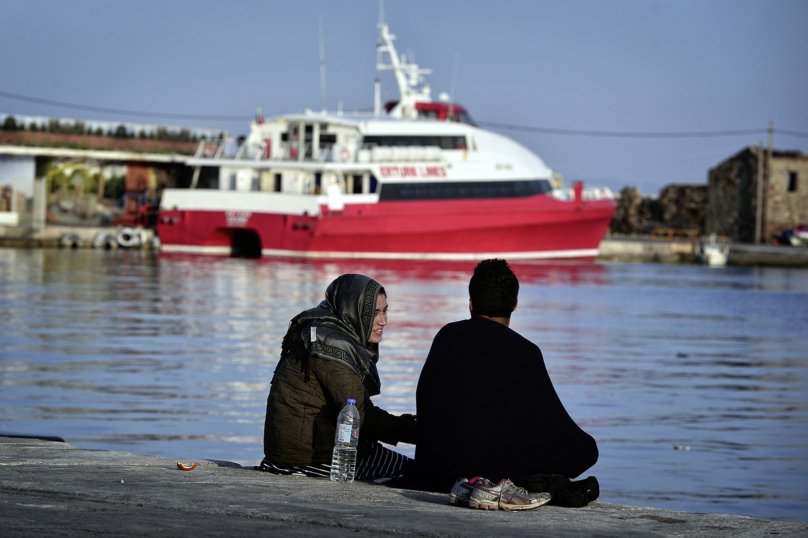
left=0, top=437, right=808, bottom=538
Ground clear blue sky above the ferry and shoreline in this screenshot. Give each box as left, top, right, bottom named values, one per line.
left=0, top=0, right=808, bottom=193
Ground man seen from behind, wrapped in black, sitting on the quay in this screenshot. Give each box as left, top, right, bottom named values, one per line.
left=415, top=260, right=598, bottom=492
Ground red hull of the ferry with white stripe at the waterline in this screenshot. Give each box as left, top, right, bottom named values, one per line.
left=157, top=195, right=616, bottom=259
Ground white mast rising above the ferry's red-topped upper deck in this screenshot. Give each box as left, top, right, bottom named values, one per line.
left=376, top=23, right=432, bottom=119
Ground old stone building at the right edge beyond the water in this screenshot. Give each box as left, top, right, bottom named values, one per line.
left=705, top=146, right=808, bottom=243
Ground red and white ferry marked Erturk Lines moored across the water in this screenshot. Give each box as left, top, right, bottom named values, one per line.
left=157, top=24, right=616, bottom=260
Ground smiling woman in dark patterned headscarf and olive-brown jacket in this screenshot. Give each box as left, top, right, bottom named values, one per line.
left=260, top=275, right=415, bottom=480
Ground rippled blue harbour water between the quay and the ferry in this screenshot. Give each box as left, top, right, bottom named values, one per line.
left=0, top=249, right=808, bottom=521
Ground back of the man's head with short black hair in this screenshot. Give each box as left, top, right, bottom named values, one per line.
left=469, top=259, right=519, bottom=318
